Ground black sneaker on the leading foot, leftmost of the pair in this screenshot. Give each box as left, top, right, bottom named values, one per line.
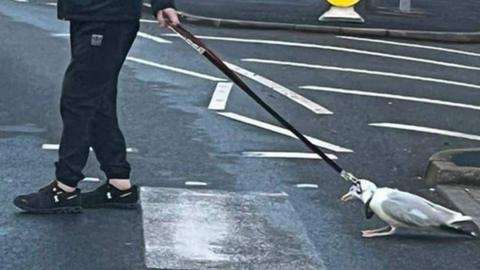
left=13, top=181, right=82, bottom=214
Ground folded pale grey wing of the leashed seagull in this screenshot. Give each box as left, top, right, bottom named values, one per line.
left=381, top=190, right=461, bottom=227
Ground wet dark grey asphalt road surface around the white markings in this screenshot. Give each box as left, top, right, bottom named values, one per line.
left=0, top=1, right=480, bottom=269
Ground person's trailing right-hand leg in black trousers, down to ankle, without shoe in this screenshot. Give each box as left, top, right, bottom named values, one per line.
left=91, top=22, right=139, bottom=190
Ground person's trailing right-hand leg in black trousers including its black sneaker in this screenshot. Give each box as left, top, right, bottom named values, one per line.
left=82, top=22, right=138, bottom=209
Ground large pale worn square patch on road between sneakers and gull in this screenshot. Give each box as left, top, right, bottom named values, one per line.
left=140, top=187, right=325, bottom=270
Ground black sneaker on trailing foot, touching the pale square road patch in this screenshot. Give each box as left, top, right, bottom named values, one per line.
left=82, top=183, right=139, bottom=209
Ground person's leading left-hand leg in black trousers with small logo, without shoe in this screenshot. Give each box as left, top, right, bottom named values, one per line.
left=56, top=21, right=113, bottom=187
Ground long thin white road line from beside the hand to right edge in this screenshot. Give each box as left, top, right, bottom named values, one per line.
left=165, top=34, right=480, bottom=70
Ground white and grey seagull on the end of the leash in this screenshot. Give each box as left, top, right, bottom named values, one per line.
left=341, top=179, right=477, bottom=238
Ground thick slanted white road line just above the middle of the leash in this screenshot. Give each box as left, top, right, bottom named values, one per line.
left=225, top=62, right=333, bottom=114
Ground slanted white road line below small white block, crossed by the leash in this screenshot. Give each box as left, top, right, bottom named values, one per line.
left=217, top=112, right=353, bottom=153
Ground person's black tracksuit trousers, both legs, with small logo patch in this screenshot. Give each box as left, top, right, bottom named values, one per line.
left=55, top=21, right=139, bottom=187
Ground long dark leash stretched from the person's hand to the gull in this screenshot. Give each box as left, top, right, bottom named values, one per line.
left=167, top=22, right=360, bottom=186
